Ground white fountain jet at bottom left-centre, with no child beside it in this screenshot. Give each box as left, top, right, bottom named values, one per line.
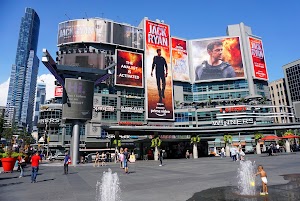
left=96, top=169, right=121, bottom=201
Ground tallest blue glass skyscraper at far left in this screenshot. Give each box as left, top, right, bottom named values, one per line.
left=7, top=8, right=40, bottom=131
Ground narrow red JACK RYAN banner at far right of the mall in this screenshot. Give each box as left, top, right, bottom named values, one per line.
left=249, top=37, right=268, bottom=80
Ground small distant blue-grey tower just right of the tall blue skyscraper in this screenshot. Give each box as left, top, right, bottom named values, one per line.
left=33, top=82, right=46, bottom=131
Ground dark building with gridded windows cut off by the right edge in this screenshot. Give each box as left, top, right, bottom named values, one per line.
left=283, top=60, right=300, bottom=122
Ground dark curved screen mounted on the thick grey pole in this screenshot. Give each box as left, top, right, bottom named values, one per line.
left=62, top=78, right=94, bottom=120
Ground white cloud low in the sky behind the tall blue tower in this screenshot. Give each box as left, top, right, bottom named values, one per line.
left=0, top=74, right=55, bottom=106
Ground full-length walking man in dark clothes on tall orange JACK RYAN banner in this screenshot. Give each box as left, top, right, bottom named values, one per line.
left=151, top=49, right=168, bottom=102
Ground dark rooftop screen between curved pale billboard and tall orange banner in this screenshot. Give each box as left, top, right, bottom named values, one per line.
left=113, top=23, right=144, bottom=49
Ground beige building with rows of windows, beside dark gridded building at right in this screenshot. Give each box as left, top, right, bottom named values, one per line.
left=269, top=78, right=293, bottom=123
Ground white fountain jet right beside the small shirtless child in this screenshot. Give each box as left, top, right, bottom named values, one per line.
left=237, top=161, right=256, bottom=195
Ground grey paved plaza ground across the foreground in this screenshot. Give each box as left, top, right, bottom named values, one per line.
left=0, top=152, right=300, bottom=201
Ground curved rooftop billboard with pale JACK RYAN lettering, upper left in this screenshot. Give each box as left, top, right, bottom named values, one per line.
left=57, top=19, right=111, bottom=46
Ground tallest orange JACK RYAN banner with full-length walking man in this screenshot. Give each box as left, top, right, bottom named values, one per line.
left=144, top=20, right=174, bottom=120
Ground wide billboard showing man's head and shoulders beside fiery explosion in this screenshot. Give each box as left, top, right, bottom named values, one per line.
left=190, top=37, right=244, bottom=82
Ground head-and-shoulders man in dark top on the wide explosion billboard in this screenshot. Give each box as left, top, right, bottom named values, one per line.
left=195, top=40, right=236, bottom=81
